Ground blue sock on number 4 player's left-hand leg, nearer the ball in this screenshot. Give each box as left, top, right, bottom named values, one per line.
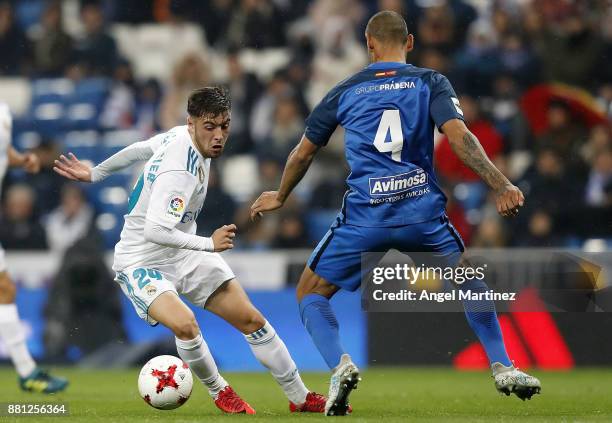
left=300, top=294, right=344, bottom=369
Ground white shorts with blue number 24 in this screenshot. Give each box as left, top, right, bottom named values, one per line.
left=115, top=251, right=235, bottom=326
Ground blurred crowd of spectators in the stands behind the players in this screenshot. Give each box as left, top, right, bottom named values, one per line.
left=0, top=0, right=612, bottom=251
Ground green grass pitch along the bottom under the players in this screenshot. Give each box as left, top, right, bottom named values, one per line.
left=0, top=367, right=612, bottom=423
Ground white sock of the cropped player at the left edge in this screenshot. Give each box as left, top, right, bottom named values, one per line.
left=0, top=304, right=36, bottom=377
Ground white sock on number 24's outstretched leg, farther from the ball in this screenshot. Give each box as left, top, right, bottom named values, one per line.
left=244, top=322, right=308, bottom=405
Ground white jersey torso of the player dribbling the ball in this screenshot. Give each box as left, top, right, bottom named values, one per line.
left=113, top=126, right=210, bottom=271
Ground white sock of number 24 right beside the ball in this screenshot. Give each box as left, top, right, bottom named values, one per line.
left=176, top=334, right=228, bottom=399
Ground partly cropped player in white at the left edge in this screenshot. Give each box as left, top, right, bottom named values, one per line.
left=0, top=102, right=68, bottom=394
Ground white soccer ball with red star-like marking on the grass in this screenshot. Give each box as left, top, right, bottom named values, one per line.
left=138, top=355, right=193, bottom=410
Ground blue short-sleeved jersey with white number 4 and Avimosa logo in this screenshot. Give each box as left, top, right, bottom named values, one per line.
left=305, top=62, right=463, bottom=227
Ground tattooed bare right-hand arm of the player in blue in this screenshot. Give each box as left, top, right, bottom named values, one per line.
left=442, top=119, right=525, bottom=216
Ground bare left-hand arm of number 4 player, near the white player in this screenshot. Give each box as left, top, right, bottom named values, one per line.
left=251, top=135, right=320, bottom=220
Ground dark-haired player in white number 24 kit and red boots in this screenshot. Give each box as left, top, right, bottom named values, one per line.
left=55, top=87, right=325, bottom=414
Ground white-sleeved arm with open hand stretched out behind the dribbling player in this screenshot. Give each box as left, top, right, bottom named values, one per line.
left=53, top=140, right=159, bottom=182
